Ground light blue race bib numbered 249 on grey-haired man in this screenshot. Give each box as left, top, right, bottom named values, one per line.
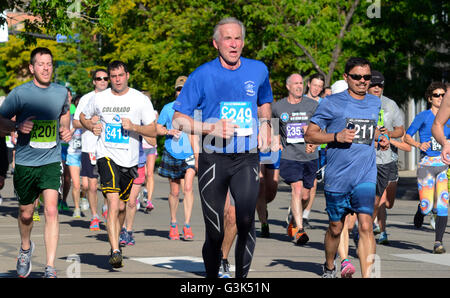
left=220, top=101, right=253, bottom=136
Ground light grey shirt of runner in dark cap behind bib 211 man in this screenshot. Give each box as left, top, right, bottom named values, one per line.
left=376, top=95, right=405, bottom=164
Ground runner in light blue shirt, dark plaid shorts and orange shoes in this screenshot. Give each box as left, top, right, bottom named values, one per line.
left=156, top=76, right=198, bottom=240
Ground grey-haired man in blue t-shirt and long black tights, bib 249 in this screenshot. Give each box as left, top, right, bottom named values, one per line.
left=173, top=18, right=273, bottom=278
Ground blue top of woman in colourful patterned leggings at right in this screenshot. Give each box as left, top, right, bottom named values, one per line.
left=406, top=110, right=450, bottom=157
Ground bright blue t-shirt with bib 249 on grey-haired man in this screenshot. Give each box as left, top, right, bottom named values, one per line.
left=173, top=57, right=273, bottom=153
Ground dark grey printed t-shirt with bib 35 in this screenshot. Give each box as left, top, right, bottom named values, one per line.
left=272, top=96, right=319, bottom=161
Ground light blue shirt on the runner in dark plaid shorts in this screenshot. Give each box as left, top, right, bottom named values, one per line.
left=157, top=101, right=194, bottom=159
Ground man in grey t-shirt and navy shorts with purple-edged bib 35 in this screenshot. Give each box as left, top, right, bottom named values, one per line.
left=272, top=74, right=319, bottom=245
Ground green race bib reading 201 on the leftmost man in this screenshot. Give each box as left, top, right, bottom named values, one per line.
left=30, top=120, right=57, bottom=149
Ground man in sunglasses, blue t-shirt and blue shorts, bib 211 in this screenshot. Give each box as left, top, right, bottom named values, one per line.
left=305, top=58, right=388, bottom=277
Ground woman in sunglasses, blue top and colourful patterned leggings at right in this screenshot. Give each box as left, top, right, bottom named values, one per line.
left=405, top=82, right=450, bottom=254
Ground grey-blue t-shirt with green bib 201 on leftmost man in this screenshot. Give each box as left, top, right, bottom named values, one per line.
left=0, top=81, right=69, bottom=166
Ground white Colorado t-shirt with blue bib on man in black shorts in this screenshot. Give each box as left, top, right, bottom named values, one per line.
left=83, top=88, right=155, bottom=168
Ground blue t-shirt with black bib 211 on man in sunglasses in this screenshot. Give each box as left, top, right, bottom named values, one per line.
left=310, top=90, right=381, bottom=193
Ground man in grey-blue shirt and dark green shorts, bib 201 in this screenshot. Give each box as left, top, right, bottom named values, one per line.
left=0, top=47, right=71, bottom=278
